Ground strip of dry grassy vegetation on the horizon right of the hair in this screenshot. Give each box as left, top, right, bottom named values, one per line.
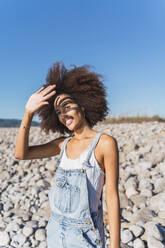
left=104, top=115, right=165, bottom=124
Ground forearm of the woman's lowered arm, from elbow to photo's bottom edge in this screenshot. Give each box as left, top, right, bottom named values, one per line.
left=106, top=194, right=121, bottom=248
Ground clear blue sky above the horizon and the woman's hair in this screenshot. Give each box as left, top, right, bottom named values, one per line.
left=0, top=0, right=165, bottom=119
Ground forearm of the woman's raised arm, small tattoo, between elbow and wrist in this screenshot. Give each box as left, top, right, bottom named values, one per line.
left=15, top=111, right=33, bottom=159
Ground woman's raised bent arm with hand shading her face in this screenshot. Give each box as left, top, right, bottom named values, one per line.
left=15, top=85, right=64, bottom=159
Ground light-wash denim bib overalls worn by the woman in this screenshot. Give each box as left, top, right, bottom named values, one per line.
left=46, top=132, right=105, bottom=248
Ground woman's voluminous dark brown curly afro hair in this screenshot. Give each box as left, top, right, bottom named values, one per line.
left=37, top=62, right=108, bottom=134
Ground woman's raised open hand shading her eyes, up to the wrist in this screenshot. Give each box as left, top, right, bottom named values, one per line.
left=25, top=84, right=56, bottom=114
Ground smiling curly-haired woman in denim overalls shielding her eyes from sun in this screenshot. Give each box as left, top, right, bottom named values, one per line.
left=15, top=62, right=120, bottom=248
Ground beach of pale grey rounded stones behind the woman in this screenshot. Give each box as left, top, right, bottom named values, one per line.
left=0, top=122, right=165, bottom=248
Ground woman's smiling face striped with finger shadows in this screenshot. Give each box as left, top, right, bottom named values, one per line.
left=54, top=94, right=85, bottom=130
